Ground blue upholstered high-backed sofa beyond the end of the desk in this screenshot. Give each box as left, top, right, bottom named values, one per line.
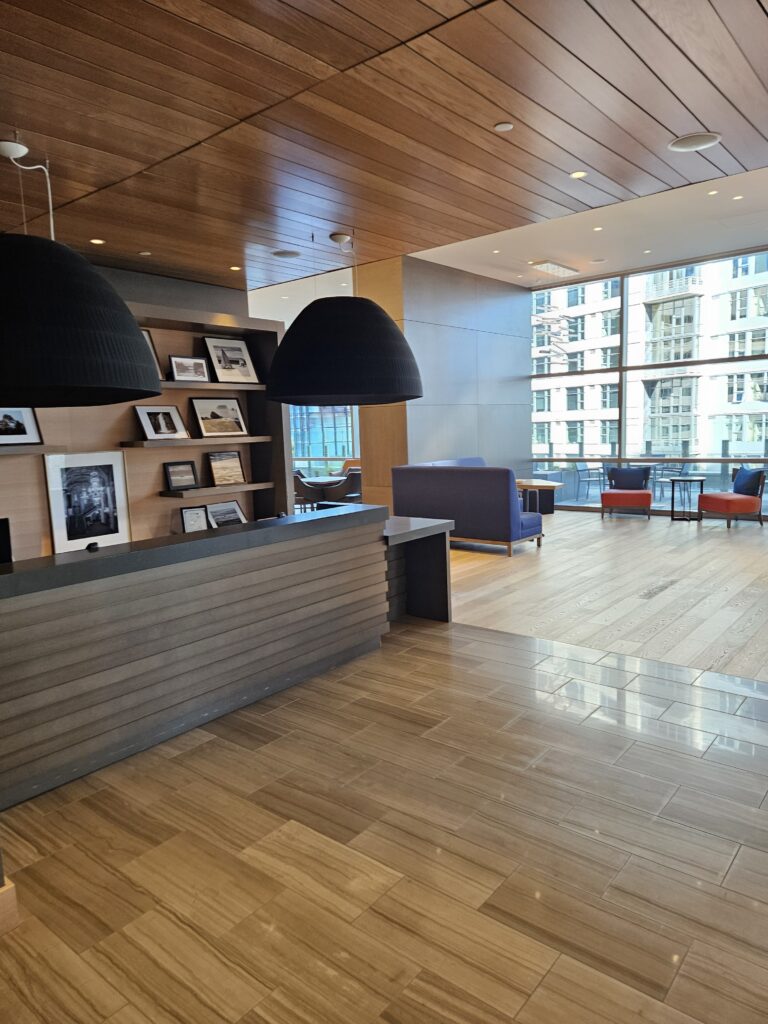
left=392, top=457, right=544, bottom=555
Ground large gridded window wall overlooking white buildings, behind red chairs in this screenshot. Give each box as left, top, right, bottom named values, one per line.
left=531, top=253, right=768, bottom=508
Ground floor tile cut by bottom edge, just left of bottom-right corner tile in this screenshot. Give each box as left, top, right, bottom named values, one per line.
left=515, top=956, right=697, bottom=1024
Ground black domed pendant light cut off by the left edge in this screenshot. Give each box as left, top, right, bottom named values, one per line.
left=0, top=234, right=161, bottom=408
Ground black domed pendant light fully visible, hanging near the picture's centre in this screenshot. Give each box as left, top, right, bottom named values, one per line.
left=266, top=296, right=423, bottom=406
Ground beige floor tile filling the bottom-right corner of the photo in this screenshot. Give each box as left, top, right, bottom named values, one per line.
left=667, top=942, right=768, bottom=1024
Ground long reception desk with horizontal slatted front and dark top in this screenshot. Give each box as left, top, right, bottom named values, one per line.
left=0, top=505, right=388, bottom=808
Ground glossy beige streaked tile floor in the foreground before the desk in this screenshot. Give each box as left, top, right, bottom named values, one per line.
left=0, top=618, right=768, bottom=1024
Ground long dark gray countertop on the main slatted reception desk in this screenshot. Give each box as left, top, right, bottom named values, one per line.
left=0, top=505, right=387, bottom=599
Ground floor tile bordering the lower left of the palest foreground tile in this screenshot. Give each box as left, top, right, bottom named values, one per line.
left=123, top=833, right=283, bottom=935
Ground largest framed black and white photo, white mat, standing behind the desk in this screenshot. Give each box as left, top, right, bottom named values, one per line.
left=45, top=452, right=131, bottom=554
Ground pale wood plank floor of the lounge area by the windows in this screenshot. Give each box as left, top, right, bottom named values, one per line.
left=452, top=512, right=768, bottom=679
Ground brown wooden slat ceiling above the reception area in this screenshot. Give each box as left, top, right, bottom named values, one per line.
left=0, top=0, right=768, bottom=288
